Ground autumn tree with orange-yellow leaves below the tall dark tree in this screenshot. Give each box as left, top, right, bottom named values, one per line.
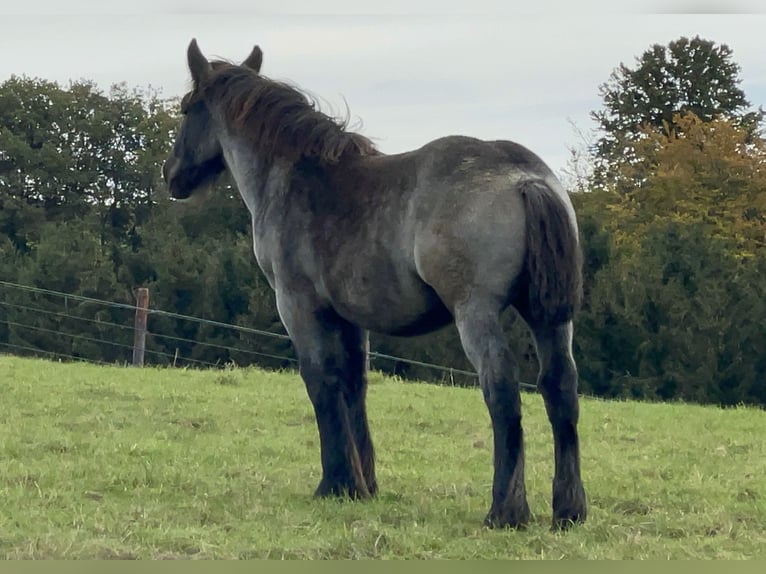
left=607, top=112, right=766, bottom=256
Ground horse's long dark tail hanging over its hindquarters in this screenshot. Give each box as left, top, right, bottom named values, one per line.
left=518, top=180, right=582, bottom=325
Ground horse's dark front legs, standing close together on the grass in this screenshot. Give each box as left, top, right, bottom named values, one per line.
left=278, top=294, right=377, bottom=498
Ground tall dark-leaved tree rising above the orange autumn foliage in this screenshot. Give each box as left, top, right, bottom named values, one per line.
left=591, top=36, right=763, bottom=191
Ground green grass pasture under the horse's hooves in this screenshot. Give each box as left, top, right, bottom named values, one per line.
left=0, top=356, right=766, bottom=559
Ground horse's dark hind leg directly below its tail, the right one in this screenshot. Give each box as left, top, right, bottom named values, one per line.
left=532, top=322, right=587, bottom=528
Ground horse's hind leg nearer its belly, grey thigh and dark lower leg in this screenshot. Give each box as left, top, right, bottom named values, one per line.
left=455, top=297, right=530, bottom=528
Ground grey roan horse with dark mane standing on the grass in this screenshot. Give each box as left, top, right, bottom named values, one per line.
left=162, top=39, right=587, bottom=528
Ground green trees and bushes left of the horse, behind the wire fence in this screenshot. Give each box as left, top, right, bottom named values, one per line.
left=0, top=77, right=291, bottom=367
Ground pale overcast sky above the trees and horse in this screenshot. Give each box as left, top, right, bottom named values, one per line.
left=0, top=0, right=766, bottom=181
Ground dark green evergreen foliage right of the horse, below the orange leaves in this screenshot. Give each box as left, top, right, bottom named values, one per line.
left=575, top=218, right=766, bottom=405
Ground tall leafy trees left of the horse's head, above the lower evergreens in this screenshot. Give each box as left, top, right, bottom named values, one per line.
left=0, top=76, right=175, bottom=250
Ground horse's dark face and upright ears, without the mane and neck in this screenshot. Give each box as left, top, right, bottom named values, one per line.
left=162, top=40, right=263, bottom=199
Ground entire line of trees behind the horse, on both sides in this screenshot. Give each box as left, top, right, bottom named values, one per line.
left=0, top=38, right=766, bottom=405
